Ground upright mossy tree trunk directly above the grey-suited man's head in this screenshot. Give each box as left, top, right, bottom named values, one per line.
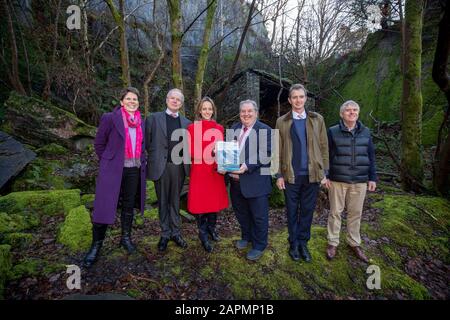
left=167, top=0, right=183, bottom=90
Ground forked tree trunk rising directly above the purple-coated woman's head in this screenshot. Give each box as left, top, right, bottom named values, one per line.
left=105, top=0, right=131, bottom=87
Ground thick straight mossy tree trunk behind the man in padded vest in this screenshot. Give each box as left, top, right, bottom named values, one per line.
left=401, top=0, right=423, bottom=191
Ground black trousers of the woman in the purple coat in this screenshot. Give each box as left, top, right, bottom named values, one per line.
left=120, top=167, right=141, bottom=213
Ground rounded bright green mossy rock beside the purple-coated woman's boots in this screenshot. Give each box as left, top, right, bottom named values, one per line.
left=58, top=206, right=92, bottom=252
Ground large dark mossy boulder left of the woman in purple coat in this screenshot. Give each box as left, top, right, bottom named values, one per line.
left=2, top=91, right=96, bottom=148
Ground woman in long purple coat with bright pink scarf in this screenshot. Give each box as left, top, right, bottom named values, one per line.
left=83, top=87, right=146, bottom=268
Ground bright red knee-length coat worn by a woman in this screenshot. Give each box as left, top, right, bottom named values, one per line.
left=187, top=120, right=228, bottom=214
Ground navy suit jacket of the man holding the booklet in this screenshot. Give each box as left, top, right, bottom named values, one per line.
left=231, top=120, right=272, bottom=198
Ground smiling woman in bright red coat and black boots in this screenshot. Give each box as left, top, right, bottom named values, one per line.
left=187, top=97, right=228, bottom=252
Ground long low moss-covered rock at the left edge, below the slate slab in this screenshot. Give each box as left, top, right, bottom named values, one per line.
left=0, top=189, right=80, bottom=215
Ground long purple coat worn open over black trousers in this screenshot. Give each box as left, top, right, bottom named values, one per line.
left=92, top=107, right=147, bottom=224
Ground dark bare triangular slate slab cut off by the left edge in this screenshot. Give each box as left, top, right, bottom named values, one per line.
left=0, top=131, right=36, bottom=189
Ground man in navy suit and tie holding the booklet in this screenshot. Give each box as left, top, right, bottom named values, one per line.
left=229, top=100, right=272, bottom=260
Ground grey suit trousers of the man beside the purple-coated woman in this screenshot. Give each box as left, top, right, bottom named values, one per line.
left=155, top=162, right=185, bottom=238
